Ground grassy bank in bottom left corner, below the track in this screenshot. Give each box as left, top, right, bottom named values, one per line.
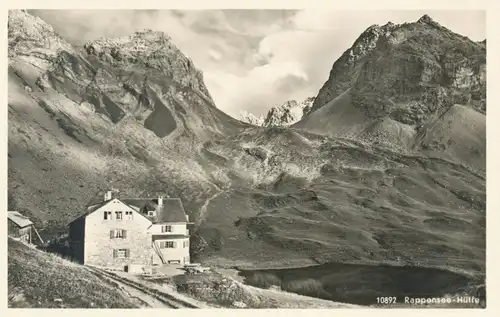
left=8, top=239, right=137, bottom=308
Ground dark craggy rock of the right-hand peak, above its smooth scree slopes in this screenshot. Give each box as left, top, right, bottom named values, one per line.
left=312, top=15, right=486, bottom=117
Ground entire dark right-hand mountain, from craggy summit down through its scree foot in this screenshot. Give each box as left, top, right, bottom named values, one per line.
left=293, top=15, right=486, bottom=168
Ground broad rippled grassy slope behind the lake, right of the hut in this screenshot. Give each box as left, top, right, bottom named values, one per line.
left=195, top=130, right=485, bottom=273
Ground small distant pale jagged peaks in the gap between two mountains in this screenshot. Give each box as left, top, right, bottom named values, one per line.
left=241, top=97, right=314, bottom=127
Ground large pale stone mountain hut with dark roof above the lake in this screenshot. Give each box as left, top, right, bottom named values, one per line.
left=69, top=192, right=190, bottom=269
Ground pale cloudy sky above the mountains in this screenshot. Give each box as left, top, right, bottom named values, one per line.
left=30, top=9, right=486, bottom=117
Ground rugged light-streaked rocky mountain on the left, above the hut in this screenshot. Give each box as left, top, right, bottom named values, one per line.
left=9, top=11, right=247, bottom=143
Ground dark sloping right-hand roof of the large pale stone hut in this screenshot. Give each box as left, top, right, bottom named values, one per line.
left=120, top=198, right=187, bottom=223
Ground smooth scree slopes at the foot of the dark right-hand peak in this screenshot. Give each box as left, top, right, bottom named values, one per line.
left=294, top=91, right=486, bottom=172
